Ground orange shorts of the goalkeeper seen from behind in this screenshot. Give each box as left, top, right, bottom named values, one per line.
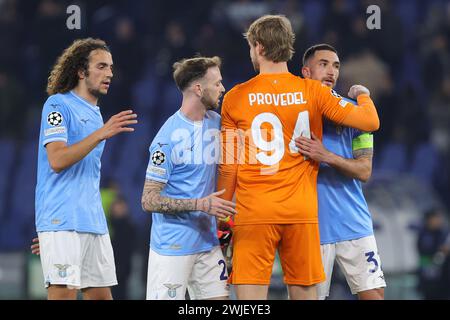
left=231, top=223, right=325, bottom=286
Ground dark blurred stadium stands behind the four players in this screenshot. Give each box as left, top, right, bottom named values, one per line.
left=0, top=0, right=450, bottom=299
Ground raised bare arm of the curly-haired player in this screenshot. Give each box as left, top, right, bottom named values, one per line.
left=46, top=110, right=137, bottom=173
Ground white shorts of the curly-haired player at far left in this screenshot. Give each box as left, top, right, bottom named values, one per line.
left=38, top=231, right=117, bottom=289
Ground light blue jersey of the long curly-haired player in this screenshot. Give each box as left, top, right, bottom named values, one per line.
left=35, top=91, right=108, bottom=234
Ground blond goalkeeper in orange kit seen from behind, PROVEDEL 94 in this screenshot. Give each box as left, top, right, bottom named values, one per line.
left=218, top=15, right=379, bottom=299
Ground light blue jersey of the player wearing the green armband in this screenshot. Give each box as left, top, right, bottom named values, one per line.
left=317, top=99, right=373, bottom=244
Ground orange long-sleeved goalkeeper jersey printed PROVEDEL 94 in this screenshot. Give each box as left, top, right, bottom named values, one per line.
left=217, top=73, right=379, bottom=225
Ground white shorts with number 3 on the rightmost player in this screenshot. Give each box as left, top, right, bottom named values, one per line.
left=317, top=235, right=386, bottom=300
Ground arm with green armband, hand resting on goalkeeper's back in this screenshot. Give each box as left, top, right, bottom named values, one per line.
left=295, top=132, right=373, bottom=182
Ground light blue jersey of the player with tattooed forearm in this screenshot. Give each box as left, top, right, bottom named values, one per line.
left=146, top=110, right=220, bottom=256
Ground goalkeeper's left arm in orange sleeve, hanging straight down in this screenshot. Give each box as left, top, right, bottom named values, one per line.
left=217, top=95, right=241, bottom=201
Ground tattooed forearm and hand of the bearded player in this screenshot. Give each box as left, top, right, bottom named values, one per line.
left=142, top=179, right=236, bottom=218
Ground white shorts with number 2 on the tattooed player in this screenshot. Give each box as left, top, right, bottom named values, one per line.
left=147, top=247, right=230, bottom=300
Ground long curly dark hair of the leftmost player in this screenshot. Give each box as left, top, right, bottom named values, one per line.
left=47, top=38, right=110, bottom=95
